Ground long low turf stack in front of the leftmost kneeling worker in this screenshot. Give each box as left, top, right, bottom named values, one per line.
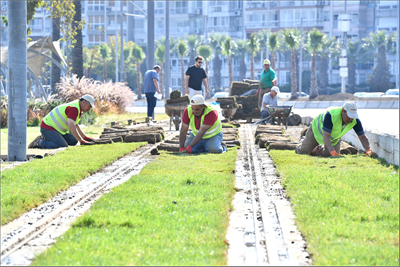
left=95, top=126, right=165, bottom=144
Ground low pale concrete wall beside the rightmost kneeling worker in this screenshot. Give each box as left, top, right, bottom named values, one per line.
left=301, top=116, right=399, bottom=165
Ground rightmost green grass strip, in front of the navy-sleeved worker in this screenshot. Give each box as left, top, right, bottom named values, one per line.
left=270, top=150, right=399, bottom=266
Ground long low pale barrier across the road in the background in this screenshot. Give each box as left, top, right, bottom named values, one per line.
left=278, top=100, right=399, bottom=109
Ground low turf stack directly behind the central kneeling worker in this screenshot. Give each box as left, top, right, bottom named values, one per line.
left=151, top=128, right=240, bottom=155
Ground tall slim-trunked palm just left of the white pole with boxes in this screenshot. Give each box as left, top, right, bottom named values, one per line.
left=308, top=28, right=324, bottom=99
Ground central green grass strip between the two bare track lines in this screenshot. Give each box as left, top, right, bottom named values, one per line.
left=33, top=149, right=236, bottom=266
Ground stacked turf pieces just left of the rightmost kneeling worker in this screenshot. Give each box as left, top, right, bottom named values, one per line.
left=254, top=125, right=297, bottom=150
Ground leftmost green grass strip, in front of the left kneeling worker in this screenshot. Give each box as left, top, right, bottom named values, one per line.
left=1, top=143, right=145, bottom=225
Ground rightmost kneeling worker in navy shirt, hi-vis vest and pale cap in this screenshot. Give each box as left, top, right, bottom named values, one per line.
left=296, top=102, right=374, bottom=157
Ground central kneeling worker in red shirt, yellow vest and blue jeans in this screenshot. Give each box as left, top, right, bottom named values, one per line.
left=179, top=95, right=227, bottom=154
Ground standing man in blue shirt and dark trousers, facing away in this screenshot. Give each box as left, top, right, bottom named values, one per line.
left=143, top=65, right=161, bottom=119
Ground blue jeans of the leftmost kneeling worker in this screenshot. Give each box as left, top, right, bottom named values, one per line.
left=38, top=127, right=78, bottom=149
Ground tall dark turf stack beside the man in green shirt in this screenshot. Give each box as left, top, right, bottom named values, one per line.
left=230, top=79, right=260, bottom=120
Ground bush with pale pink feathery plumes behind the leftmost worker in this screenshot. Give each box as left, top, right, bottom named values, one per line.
left=57, top=75, right=135, bottom=115
